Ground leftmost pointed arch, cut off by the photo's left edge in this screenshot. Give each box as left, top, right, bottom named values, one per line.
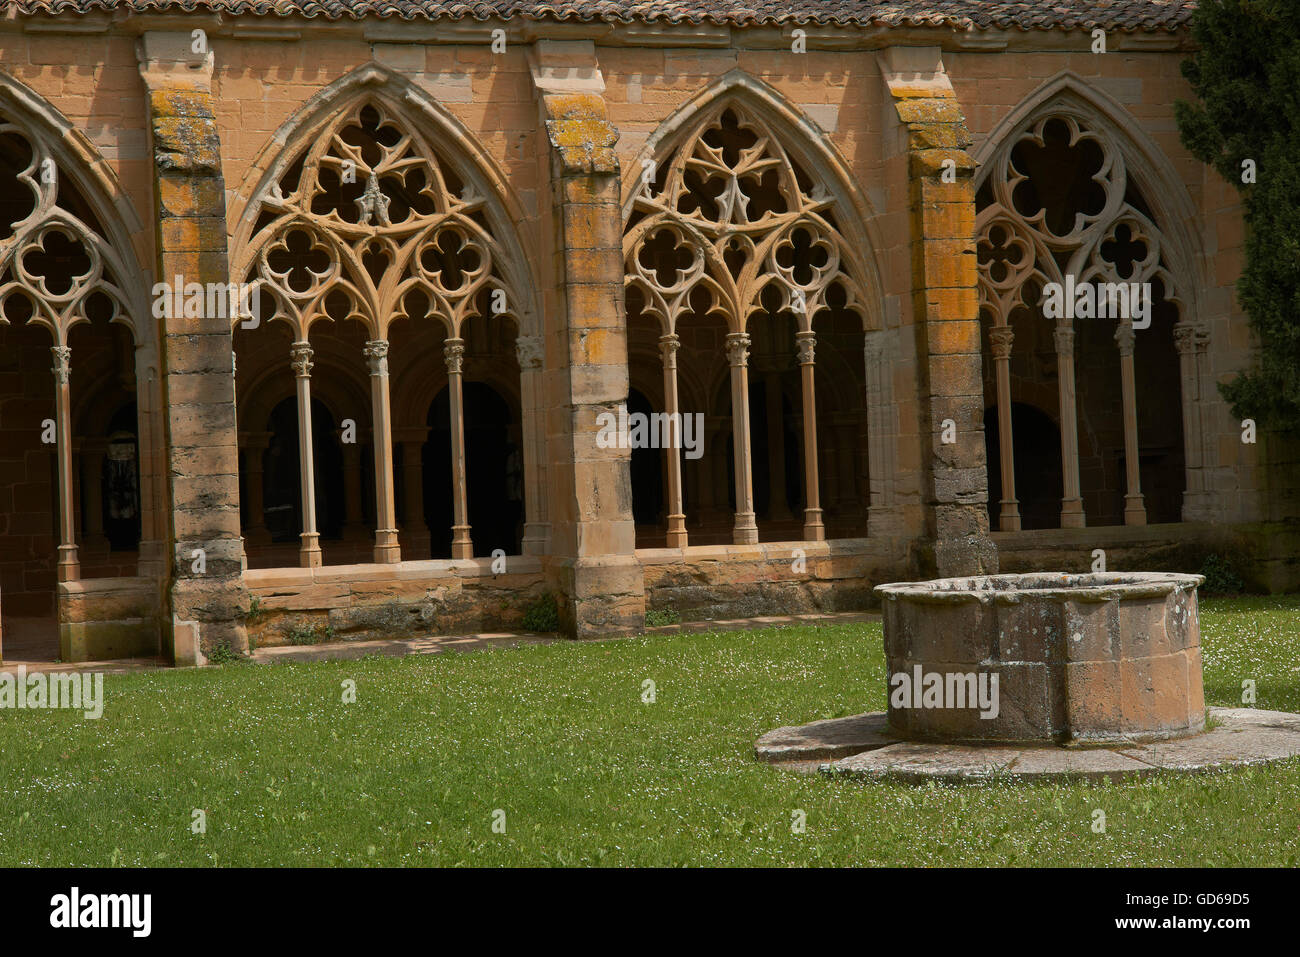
left=0, top=73, right=163, bottom=657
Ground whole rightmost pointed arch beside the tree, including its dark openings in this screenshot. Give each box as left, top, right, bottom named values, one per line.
left=975, top=73, right=1208, bottom=531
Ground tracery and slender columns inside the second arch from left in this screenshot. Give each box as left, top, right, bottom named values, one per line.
left=234, top=96, right=542, bottom=566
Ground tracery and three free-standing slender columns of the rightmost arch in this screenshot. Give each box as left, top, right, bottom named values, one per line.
left=975, top=90, right=1192, bottom=531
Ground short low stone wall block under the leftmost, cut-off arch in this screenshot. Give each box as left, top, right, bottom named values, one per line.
left=57, top=577, right=161, bottom=662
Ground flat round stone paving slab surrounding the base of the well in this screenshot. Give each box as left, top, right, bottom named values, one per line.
left=754, top=707, right=1300, bottom=784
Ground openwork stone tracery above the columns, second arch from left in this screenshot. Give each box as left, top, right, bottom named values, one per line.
left=247, top=103, right=519, bottom=339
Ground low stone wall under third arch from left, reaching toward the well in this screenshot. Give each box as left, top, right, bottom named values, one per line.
left=637, top=538, right=906, bottom=622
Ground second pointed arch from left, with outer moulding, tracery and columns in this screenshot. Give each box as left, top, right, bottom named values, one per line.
left=231, top=64, right=540, bottom=566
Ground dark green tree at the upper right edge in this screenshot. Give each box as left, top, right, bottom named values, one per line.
left=1175, top=0, right=1300, bottom=430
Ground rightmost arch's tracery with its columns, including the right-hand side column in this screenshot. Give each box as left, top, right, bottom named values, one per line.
left=975, top=101, right=1208, bottom=531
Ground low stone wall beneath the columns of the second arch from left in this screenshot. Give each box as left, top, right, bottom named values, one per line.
left=243, top=555, right=546, bottom=646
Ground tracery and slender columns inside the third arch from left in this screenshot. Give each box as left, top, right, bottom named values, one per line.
left=623, top=98, right=883, bottom=547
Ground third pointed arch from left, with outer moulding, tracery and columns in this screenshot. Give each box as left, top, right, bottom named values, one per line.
left=624, top=70, right=883, bottom=547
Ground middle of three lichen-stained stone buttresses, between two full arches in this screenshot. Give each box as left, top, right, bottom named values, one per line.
left=529, top=39, right=645, bottom=637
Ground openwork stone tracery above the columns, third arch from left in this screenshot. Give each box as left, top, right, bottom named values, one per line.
left=623, top=104, right=865, bottom=334
